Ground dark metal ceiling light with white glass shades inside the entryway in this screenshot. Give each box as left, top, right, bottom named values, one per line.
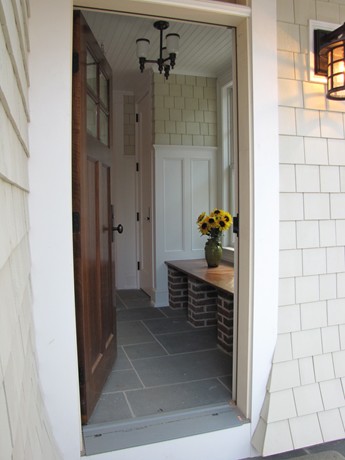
left=136, top=21, right=180, bottom=79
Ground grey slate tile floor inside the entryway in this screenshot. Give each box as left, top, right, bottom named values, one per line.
left=89, top=290, right=231, bottom=425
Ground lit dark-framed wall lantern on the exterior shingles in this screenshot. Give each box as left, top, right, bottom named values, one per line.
left=314, top=23, right=345, bottom=101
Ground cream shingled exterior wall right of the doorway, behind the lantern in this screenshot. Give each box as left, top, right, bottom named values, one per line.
left=253, top=0, right=345, bottom=455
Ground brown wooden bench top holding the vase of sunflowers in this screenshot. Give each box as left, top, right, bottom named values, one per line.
left=165, top=259, right=234, bottom=294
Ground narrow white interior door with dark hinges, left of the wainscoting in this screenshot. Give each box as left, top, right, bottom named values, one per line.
left=137, top=92, right=154, bottom=296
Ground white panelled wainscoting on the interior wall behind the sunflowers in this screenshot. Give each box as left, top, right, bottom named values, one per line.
left=153, top=145, right=217, bottom=307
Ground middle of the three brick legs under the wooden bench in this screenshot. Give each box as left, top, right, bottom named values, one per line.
left=188, top=278, right=217, bottom=327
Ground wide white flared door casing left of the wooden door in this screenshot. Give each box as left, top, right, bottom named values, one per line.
left=29, top=0, right=80, bottom=459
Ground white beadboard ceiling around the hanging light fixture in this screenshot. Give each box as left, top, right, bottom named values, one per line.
left=83, top=11, right=232, bottom=90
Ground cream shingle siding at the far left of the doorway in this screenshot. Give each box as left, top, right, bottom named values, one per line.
left=0, top=0, right=58, bottom=460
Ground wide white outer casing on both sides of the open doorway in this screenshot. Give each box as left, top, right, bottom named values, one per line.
left=28, top=0, right=279, bottom=459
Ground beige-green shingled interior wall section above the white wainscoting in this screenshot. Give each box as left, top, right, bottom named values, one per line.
left=153, top=74, right=217, bottom=147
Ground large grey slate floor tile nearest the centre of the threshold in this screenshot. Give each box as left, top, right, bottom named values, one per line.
left=126, top=379, right=231, bottom=417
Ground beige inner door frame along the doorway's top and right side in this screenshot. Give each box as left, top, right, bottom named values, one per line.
left=74, top=0, right=254, bottom=418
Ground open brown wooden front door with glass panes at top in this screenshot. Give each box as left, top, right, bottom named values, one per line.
left=72, top=12, right=116, bottom=423
